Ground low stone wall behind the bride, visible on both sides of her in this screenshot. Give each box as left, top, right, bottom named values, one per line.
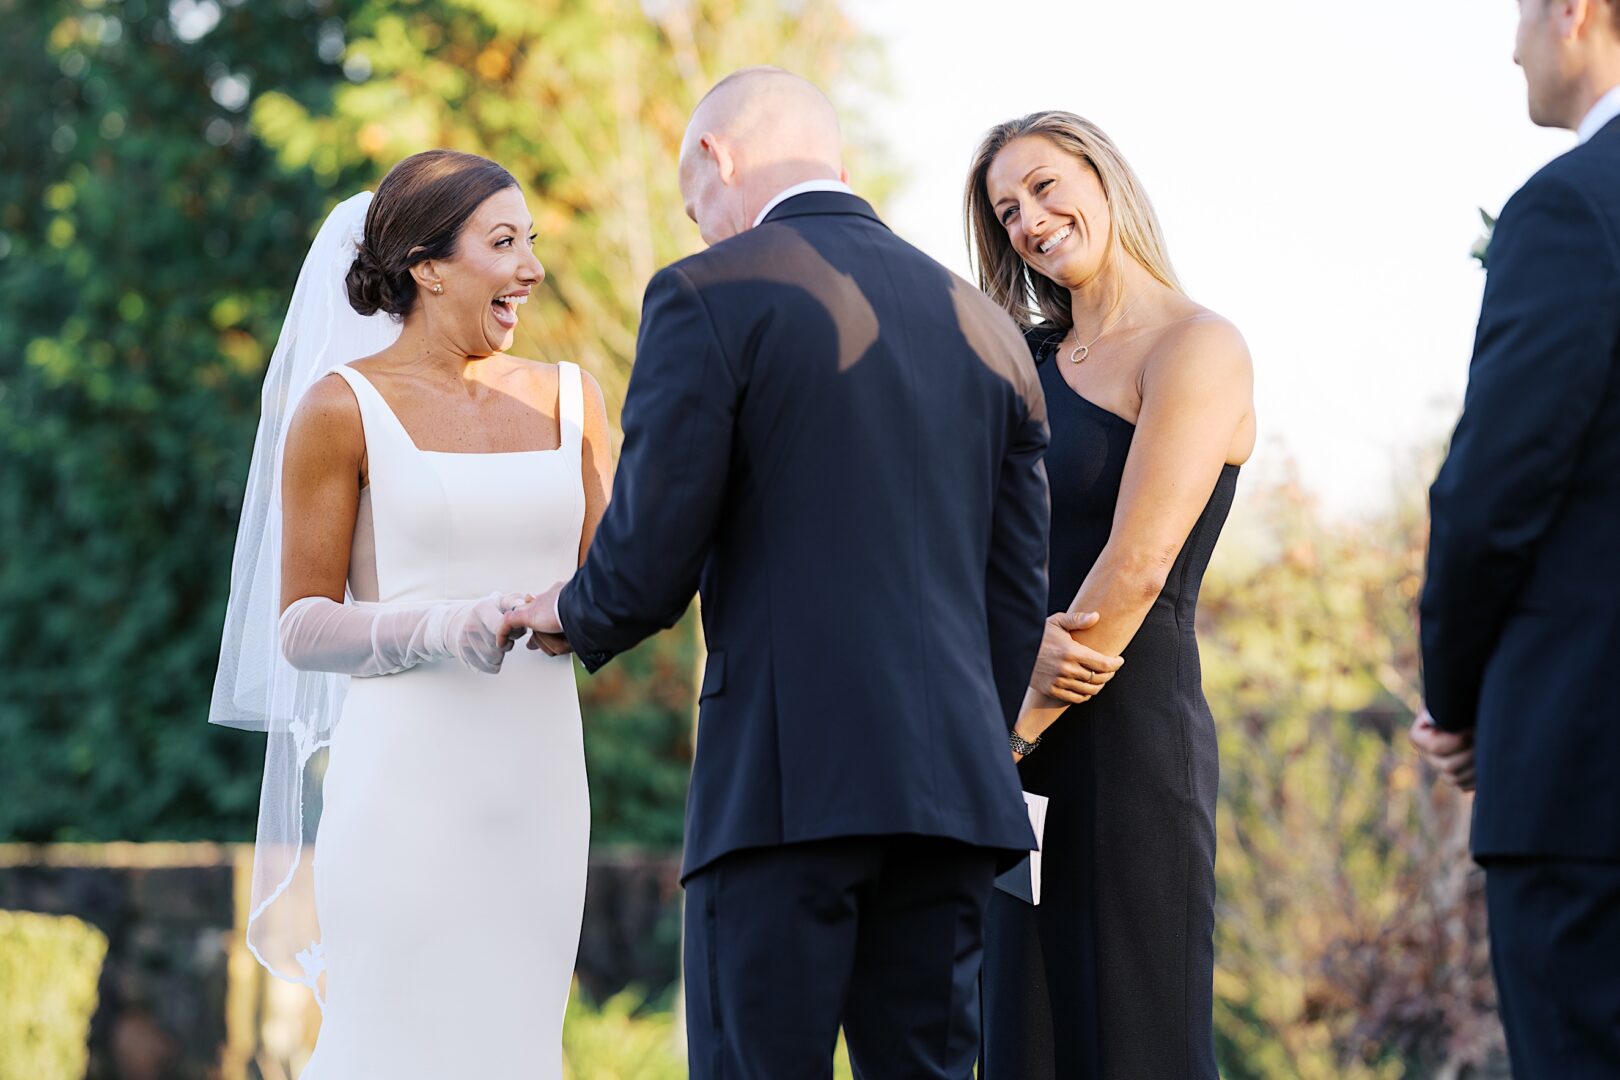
left=0, top=844, right=680, bottom=1080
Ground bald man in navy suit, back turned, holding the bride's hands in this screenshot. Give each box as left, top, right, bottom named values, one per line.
left=509, top=68, right=1048, bottom=1080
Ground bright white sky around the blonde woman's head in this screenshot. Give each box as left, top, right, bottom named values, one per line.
left=855, top=0, right=1575, bottom=513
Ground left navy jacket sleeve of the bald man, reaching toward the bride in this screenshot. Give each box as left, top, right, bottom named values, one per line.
left=557, top=267, right=740, bottom=672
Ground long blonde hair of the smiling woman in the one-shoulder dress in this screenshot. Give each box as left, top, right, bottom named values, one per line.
left=962, top=110, right=1183, bottom=332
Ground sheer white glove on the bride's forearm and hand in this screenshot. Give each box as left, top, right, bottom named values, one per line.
left=280, top=593, right=525, bottom=675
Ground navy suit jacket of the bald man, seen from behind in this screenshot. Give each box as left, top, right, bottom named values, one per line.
left=557, top=193, right=1048, bottom=876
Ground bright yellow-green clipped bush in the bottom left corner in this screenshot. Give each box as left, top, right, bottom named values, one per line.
left=0, top=912, right=107, bottom=1080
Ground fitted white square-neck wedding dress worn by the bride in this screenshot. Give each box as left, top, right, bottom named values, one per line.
left=301, top=364, right=590, bottom=1080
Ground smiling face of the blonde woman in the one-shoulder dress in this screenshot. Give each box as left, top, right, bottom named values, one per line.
left=985, top=134, right=1113, bottom=290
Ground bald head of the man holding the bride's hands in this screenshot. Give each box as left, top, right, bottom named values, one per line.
left=680, top=68, right=846, bottom=244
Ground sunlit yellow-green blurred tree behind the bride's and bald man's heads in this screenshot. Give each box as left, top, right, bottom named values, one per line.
left=251, top=0, right=891, bottom=411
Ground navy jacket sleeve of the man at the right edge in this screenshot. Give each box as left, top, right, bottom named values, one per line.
left=1421, top=176, right=1620, bottom=730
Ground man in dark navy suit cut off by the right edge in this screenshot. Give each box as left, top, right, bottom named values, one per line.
left=1411, top=0, right=1620, bottom=1080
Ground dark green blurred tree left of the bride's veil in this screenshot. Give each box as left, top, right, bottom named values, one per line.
left=0, top=0, right=367, bottom=840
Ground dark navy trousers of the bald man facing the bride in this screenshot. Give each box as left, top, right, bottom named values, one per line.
left=685, top=836, right=1000, bottom=1080
